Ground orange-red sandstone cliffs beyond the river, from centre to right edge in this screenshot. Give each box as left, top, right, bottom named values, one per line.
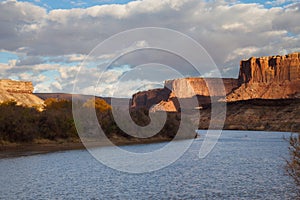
left=131, top=52, right=300, bottom=111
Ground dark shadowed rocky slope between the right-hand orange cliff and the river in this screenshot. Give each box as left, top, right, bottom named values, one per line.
left=199, top=99, right=300, bottom=132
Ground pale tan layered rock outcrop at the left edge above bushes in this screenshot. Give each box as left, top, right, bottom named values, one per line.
left=0, top=80, right=44, bottom=109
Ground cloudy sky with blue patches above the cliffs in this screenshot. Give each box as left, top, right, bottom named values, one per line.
left=0, top=0, right=300, bottom=97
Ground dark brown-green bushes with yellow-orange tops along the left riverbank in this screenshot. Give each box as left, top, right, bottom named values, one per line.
left=0, top=98, right=188, bottom=145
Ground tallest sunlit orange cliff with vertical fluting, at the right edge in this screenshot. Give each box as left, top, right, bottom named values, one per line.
left=227, top=53, right=300, bottom=101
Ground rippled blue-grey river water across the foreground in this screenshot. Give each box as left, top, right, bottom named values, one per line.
left=0, top=131, right=296, bottom=199
